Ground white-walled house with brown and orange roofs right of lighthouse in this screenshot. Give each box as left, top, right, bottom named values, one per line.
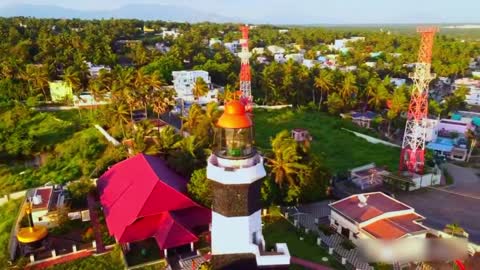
left=329, top=192, right=429, bottom=242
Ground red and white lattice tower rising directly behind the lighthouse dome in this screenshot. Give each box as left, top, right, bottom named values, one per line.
left=238, top=25, right=253, bottom=112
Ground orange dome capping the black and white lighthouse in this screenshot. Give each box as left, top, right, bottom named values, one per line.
left=217, top=100, right=252, bottom=128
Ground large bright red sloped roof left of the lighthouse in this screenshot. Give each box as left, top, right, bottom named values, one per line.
left=98, top=154, right=211, bottom=248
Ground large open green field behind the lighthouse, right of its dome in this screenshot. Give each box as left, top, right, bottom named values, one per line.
left=254, top=108, right=400, bottom=172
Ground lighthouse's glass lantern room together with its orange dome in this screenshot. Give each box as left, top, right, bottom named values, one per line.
left=214, top=100, right=255, bottom=159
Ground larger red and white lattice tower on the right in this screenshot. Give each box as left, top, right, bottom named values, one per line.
left=399, top=27, right=438, bottom=174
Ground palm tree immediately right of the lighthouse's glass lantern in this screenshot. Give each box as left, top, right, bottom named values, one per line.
left=267, top=130, right=309, bottom=186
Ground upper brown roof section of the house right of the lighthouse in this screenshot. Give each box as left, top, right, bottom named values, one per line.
left=330, top=192, right=412, bottom=223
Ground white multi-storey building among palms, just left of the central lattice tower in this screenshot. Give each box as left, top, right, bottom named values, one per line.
left=172, top=70, right=218, bottom=104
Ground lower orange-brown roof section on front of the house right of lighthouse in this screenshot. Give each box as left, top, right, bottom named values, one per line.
left=362, top=214, right=426, bottom=240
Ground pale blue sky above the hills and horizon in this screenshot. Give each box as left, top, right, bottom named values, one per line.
left=0, top=0, right=480, bottom=24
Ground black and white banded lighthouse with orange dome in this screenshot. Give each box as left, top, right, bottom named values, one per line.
left=207, top=100, right=290, bottom=269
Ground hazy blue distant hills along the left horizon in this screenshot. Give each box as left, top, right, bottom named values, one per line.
left=0, top=4, right=241, bottom=22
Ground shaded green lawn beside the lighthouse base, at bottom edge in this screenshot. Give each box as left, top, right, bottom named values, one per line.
left=263, top=217, right=344, bottom=269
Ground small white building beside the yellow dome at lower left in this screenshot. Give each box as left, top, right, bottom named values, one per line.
left=27, top=186, right=65, bottom=228
